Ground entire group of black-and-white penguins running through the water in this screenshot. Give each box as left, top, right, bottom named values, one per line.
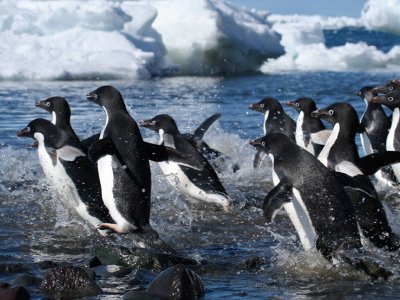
left=17, top=80, right=400, bottom=278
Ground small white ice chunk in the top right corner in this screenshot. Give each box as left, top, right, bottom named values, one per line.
left=361, top=0, right=400, bottom=35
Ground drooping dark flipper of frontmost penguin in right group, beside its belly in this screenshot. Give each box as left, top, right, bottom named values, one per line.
left=262, top=180, right=292, bottom=223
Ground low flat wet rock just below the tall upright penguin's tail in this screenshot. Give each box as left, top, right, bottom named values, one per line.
left=93, top=245, right=200, bottom=271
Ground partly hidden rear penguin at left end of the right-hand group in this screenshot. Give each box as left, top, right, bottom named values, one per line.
left=249, top=97, right=296, bottom=169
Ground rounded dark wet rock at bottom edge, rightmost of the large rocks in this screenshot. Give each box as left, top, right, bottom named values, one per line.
left=147, top=265, right=204, bottom=299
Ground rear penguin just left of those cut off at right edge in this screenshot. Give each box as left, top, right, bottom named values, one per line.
left=357, top=86, right=399, bottom=186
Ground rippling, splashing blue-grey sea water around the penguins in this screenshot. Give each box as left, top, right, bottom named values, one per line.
left=0, top=28, right=400, bottom=299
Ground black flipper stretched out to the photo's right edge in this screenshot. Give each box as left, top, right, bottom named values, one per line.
left=358, top=151, right=400, bottom=175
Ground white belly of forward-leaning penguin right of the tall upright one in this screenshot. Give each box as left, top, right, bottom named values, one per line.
left=159, top=161, right=229, bottom=207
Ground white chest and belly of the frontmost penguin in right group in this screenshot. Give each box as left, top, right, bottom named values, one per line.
left=268, top=154, right=316, bottom=250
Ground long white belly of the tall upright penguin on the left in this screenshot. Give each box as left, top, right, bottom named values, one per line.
left=97, top=155, right=136, bottom=229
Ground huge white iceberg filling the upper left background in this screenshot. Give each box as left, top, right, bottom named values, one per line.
left=0, top=0, right=283, bottom=80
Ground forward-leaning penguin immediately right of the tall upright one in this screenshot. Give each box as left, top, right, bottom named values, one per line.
left=139, top=114, right=231, bottom=210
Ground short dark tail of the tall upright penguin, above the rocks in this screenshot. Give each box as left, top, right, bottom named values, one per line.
left=133, top=225, right=177, bottom=254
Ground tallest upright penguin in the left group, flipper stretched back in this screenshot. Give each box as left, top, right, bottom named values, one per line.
left=86, top=86, right=202, bottom=253
